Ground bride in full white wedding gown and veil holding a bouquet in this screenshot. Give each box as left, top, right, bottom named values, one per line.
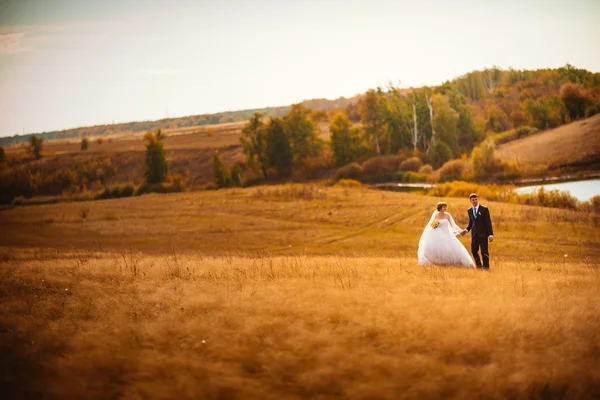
left=417, top=202, right=475, bottom=268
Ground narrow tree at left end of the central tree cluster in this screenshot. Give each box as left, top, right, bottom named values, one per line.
left=240, top=113, right=268, bottom=178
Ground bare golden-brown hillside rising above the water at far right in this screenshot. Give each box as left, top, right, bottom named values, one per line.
left=497, top=114, right=600, bottom=169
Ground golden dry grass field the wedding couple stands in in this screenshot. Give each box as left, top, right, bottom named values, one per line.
left=0, top=185, right=600, bottom=399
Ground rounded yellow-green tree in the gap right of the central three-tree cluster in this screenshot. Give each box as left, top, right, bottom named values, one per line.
left=329, top=112, right=364, bottom=167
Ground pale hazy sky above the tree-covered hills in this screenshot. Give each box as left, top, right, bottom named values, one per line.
left=0, top=0, right=600, bottom=136
